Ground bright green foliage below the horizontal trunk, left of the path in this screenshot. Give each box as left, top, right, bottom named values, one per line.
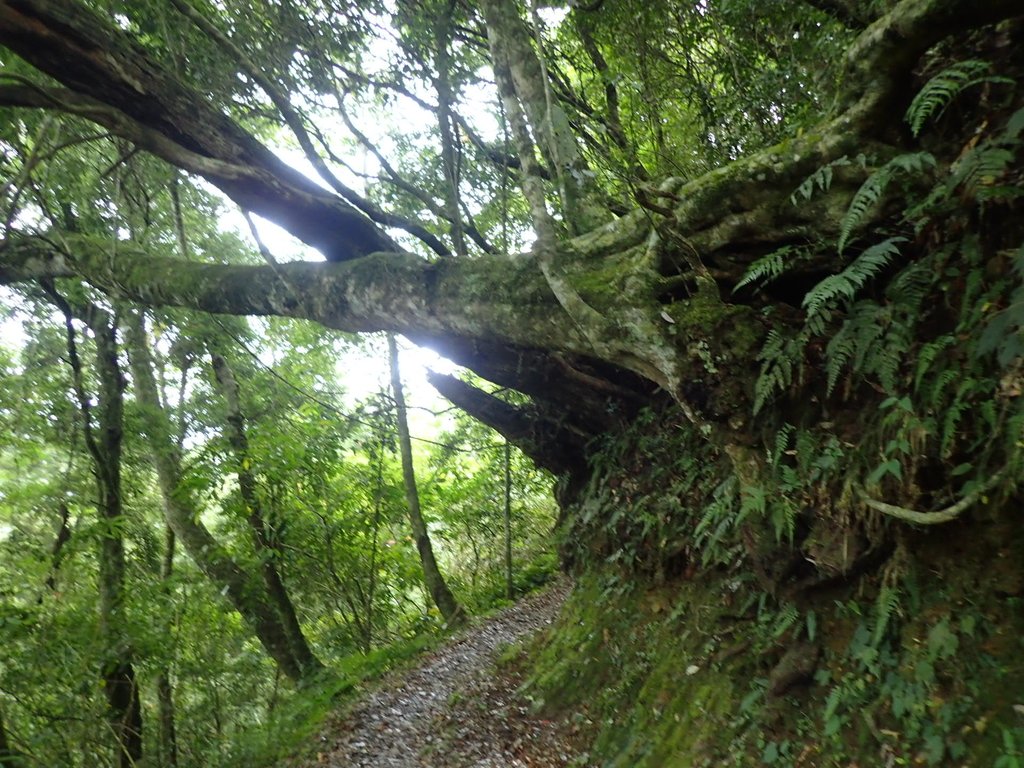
left=0, top=305, right=556, bottom=766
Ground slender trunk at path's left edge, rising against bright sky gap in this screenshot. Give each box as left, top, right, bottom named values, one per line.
left=387, top=334, right=465, bottom=625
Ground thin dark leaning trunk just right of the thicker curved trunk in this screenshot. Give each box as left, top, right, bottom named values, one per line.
left=210, top=354, right=324, bottom=675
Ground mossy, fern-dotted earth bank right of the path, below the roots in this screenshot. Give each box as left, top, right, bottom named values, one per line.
left=516, top=414, right=1024, bottom=768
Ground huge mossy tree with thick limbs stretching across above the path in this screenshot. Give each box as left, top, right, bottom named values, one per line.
left=0, top=0, right=1020, bottom=536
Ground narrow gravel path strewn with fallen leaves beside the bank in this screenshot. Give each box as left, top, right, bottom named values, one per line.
left=296, top=584, right=586, bottom=768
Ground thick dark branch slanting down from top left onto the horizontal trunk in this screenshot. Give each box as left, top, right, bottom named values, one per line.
left=0, top=0, right=396, bottom=261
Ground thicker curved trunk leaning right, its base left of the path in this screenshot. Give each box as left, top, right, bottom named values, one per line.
left=127, top=313, right=305, bottom=681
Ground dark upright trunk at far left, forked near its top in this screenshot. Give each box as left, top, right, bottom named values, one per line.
left=47, top=287, right=142, bottom=768
